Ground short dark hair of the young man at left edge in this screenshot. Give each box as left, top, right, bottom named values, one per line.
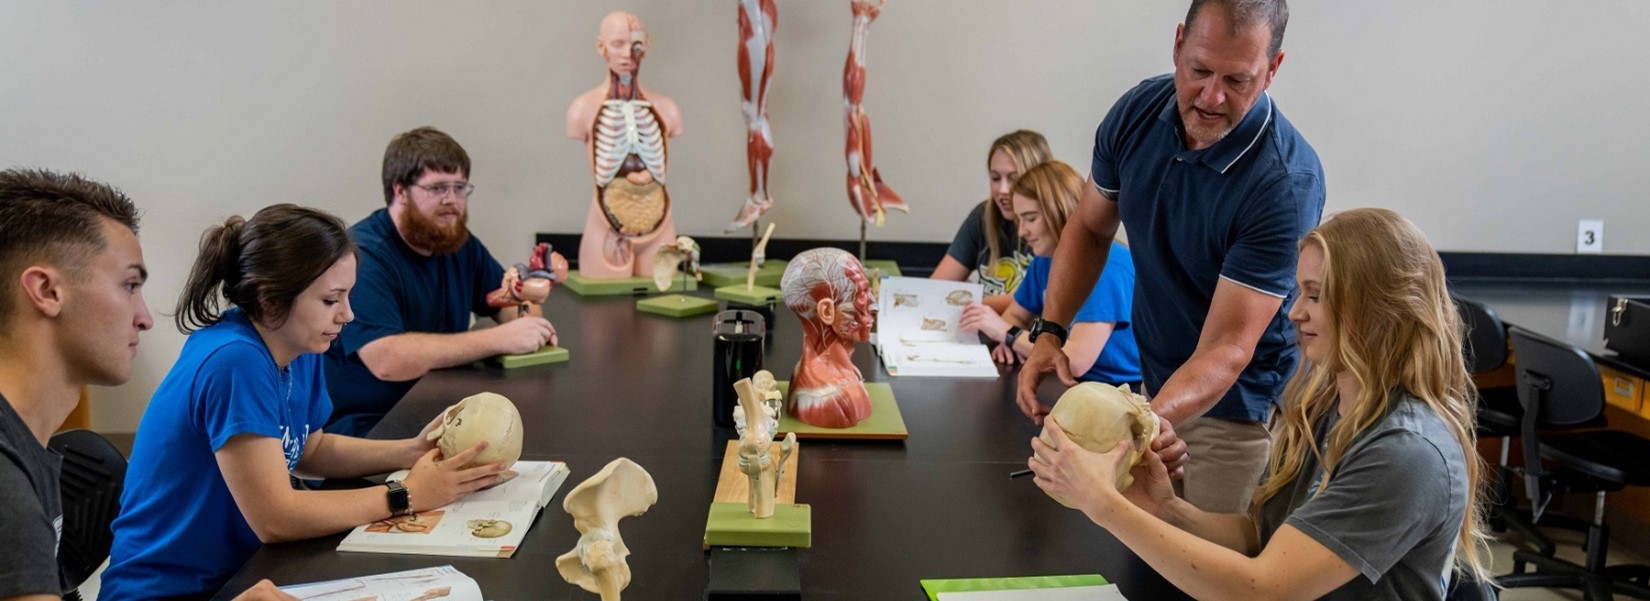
left=0, top=168, right=139, bottom=324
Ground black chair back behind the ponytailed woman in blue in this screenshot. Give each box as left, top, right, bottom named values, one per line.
left=46, top=429, right=125, bottom=601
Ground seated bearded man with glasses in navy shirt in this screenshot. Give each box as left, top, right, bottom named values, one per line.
left=327, top=127, right=556, bottom=436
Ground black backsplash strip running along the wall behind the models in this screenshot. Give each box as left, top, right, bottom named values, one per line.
left=523, top=233, right=1650, bottom=282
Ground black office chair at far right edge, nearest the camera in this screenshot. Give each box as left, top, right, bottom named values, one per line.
left=1497, top=329, right=1650, bottom=601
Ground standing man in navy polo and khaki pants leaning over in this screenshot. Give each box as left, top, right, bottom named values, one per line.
left=1018, top=0, right=1323, bottom=513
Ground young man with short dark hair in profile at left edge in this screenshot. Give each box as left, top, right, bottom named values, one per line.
left=0, top=168, right=292, bottom=601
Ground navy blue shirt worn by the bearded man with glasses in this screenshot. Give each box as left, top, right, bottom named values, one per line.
left=327, top=208, right=505, bottom=436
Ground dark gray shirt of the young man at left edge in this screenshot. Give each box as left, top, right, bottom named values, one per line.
left=0, top=396, right=64, bottom=599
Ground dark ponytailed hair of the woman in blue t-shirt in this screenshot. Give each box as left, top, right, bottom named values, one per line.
left=173, top=205, right=355, bottom=334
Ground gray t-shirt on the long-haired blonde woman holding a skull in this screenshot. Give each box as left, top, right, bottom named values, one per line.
left=1261, top=393, right=1469, bottom=601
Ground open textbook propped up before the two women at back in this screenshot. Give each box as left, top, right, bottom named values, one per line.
left=876, top=277, right=997, bottom=380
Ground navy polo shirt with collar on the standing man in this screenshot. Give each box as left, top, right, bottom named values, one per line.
left=1091, top=74, right=1325, bottom=421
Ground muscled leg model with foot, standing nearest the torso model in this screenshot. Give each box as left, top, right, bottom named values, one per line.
left=728, top=0, right=779, bottom=231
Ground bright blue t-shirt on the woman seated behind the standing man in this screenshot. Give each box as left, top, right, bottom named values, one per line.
left=1015, top=243, right=1140, bottom=385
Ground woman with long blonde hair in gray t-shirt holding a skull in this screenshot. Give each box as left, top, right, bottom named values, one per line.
left=1030, top=208, right=1488, bottom=599
